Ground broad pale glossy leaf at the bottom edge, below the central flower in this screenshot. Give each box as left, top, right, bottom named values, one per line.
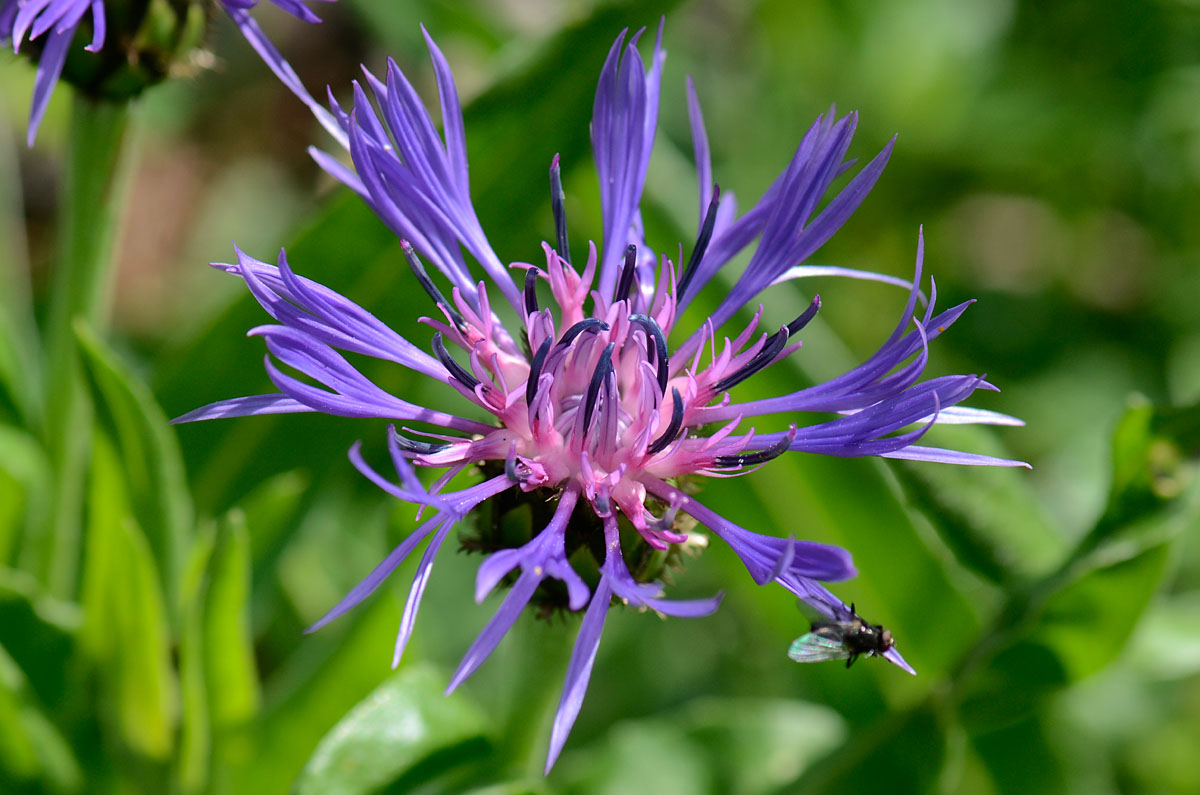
left=295, top=667, right=487, bottom=795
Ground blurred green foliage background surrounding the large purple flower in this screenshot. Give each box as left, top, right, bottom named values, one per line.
left=0, top=0, right=1200, bottom=795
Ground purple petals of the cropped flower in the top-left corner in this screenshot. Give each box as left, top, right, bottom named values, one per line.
left=0, top=0, right=341, bottom=147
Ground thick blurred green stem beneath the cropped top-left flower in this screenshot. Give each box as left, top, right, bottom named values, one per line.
left=36, top=94, right=128, bottom=598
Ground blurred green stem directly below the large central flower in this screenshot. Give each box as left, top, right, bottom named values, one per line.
left=500, top=614, right=577, bottom=782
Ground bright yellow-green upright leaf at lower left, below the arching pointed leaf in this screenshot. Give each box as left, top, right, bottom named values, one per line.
left=80, top=434, right=178, bottom=759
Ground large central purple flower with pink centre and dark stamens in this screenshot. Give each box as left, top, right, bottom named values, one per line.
left=175, top=28, right=1020, bottom=771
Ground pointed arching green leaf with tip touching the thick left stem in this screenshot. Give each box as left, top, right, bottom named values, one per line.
left=76, top=324, right=193, bottom=604
